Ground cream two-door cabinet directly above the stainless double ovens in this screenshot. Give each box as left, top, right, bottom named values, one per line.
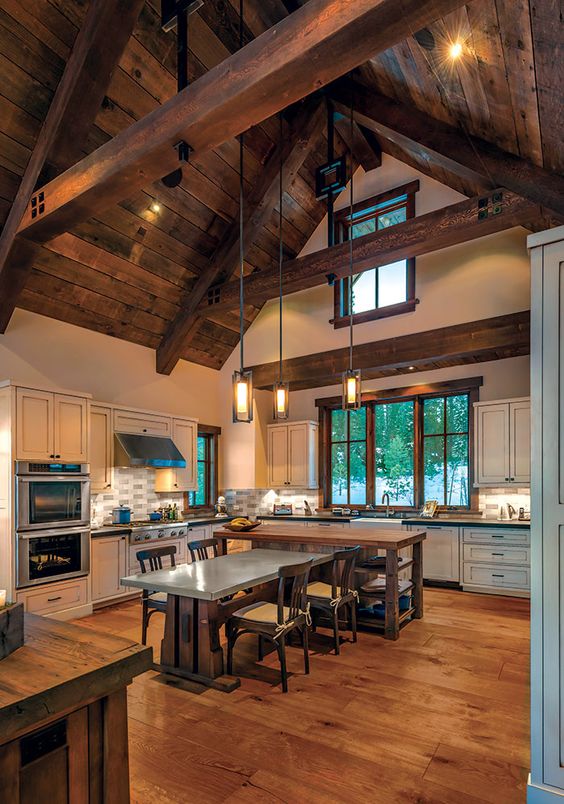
left=16, top=388, right=88, bottom=463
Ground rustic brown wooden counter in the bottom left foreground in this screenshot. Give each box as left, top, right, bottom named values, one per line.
left=0, top=614, right=152, bottom=804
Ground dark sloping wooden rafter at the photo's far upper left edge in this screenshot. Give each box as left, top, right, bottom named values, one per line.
left=0, top=0, right=143, bottom=332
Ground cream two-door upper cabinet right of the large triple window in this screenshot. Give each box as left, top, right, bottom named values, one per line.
left=474, top=398, right=531, bottom=486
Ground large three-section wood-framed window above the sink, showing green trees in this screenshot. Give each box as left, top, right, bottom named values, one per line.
left=320, top=380, right=479, bottom=510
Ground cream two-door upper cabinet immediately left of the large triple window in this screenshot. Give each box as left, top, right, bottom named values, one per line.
left=268, top=422, right=318, bottom=489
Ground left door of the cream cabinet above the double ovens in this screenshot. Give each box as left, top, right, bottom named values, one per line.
left=16, top=388, right=55, bottom=461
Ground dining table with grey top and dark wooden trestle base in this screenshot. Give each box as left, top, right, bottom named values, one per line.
left=120, top=548, right=332, bottom=692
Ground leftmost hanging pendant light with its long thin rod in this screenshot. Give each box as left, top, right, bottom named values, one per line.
left=233, top=0, right=253, bottom=423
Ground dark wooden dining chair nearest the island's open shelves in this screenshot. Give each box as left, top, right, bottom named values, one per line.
left=307, top=545, right=360, bottom=655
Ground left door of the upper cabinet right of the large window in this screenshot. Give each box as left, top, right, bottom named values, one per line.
left=475, top=402, right=510, bottom=485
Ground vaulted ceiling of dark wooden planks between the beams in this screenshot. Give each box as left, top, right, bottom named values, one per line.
left=0, top=0, right=564, bottom=368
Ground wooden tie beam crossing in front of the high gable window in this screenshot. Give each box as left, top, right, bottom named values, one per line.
left=200, top=190, right=543, bottom=315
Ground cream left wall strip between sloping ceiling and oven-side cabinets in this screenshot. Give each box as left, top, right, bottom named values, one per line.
left=0, top=309, right=223, bottom=425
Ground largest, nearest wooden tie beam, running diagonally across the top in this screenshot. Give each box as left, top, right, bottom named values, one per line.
left=14, top=0, right=472, bottom=242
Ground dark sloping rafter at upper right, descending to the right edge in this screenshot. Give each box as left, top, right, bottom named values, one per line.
left=331, top=80, right=564, bottom=219
